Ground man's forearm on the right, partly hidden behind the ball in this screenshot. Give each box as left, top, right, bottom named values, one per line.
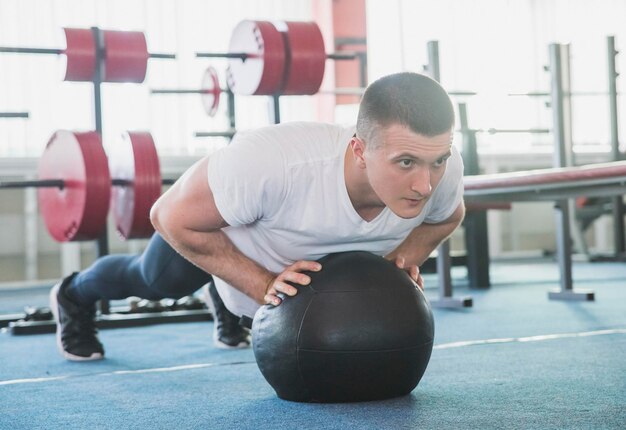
left=385, top=202, right=465, bottom=280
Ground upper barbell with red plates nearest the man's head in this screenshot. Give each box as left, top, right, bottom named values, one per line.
left=196, top=20, right=361, bottom=95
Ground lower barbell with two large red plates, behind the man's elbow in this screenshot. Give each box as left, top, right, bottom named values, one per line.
left=0, top=130, right=174, bottom=242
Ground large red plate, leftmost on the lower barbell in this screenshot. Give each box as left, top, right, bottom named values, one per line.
left=38, top=130, right=111, bottom=242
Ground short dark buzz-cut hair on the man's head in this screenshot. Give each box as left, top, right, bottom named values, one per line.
left=356, top=72, right=454, bottom=146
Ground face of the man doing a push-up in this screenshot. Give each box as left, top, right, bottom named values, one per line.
left=363, top=124, right=452, bottom=218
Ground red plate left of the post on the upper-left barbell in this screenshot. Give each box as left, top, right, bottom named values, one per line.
left=63, top=28, right=96, bottom=81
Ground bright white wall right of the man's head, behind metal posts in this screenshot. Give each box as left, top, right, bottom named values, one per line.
left=367, top=0, right=626, bottom=152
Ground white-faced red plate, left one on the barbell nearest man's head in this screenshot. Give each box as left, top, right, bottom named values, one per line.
left=228, top=21, right=285, bottom=95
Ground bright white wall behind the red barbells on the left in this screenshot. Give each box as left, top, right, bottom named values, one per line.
left=0, top=0, right=316, bottom=157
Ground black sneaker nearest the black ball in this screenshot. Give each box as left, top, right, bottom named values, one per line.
left=204, top=282, right=250, bottom=349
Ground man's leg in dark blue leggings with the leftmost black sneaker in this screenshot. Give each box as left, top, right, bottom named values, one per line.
left=50, top=234, right=249, bottom=361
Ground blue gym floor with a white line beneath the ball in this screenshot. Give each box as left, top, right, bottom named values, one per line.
left=0, top=261, right=626, bottom=430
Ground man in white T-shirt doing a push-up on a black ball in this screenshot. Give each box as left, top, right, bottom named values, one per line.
left=53, top=73, right=464, bottom=362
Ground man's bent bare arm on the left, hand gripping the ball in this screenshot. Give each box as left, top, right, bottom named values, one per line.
left=150, top=158, right=319, bottom=304
